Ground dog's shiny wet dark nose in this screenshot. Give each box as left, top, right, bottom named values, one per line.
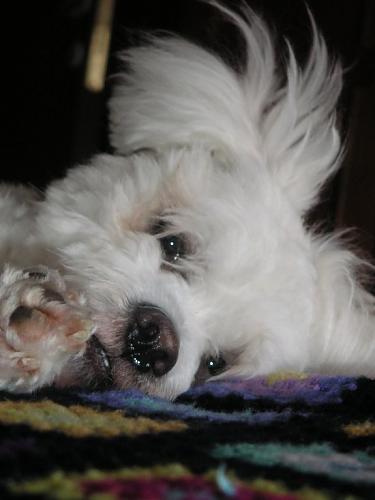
left=124, top=303, right=179, bottom=377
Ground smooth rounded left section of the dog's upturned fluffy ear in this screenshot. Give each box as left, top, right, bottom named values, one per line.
left=109, top=37, right=253, bottom=154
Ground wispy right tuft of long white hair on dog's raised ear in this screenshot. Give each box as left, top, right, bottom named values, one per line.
left=263, top=20, right=342, bottom=213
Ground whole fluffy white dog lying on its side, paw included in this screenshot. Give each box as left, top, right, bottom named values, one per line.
left=0, top=3, right=375, bottom=398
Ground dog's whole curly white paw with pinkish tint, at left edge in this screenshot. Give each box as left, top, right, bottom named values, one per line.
left=0, top=266, right=94, bottom=391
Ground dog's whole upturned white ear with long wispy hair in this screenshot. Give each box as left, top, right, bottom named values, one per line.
left=109, top=2, right=341, bottom=213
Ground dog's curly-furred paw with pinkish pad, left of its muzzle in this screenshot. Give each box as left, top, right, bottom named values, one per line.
left=0, top=274, right=94, bottom=391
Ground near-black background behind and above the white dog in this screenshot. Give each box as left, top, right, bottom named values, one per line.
left=0, top=0, right=375, bottom=255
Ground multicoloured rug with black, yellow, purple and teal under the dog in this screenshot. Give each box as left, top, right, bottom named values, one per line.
left=0, top=375, right=375, bottom=500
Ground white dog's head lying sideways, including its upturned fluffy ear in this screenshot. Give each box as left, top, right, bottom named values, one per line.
left=40, top=3, right=341, bottom=397
